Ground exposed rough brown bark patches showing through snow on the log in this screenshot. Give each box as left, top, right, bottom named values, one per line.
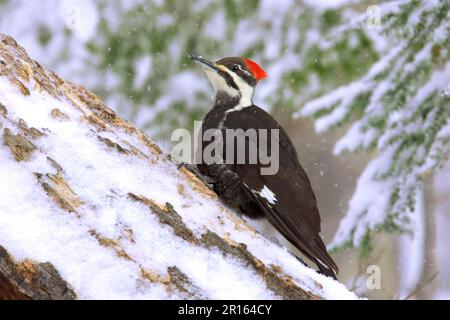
left=0, top=35, right=348, bottom=299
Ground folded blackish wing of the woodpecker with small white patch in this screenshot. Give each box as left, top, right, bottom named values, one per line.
left=224, top=106, right=338, bottom=278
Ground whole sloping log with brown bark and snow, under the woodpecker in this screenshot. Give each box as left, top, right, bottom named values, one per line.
left=0, top=35, right=356, bottom=299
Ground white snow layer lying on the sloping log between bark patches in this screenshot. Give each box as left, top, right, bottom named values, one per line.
left=0, top=70, right=356, bottom=299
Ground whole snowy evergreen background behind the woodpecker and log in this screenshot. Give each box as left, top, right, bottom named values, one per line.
left=0, top=0, right=450, bottom=299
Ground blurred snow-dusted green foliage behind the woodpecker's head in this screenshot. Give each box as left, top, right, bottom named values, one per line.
left=0, top=0, right=378, bottom=141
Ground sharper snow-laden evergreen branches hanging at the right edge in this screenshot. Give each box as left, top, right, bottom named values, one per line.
left=301, top=0, right=450, bottom=254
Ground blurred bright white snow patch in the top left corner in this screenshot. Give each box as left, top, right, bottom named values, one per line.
left=0, top=0, right=98, bottom=85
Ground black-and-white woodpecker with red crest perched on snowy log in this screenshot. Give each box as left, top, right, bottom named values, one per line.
left=189, top=55, right=338, bottom=279
